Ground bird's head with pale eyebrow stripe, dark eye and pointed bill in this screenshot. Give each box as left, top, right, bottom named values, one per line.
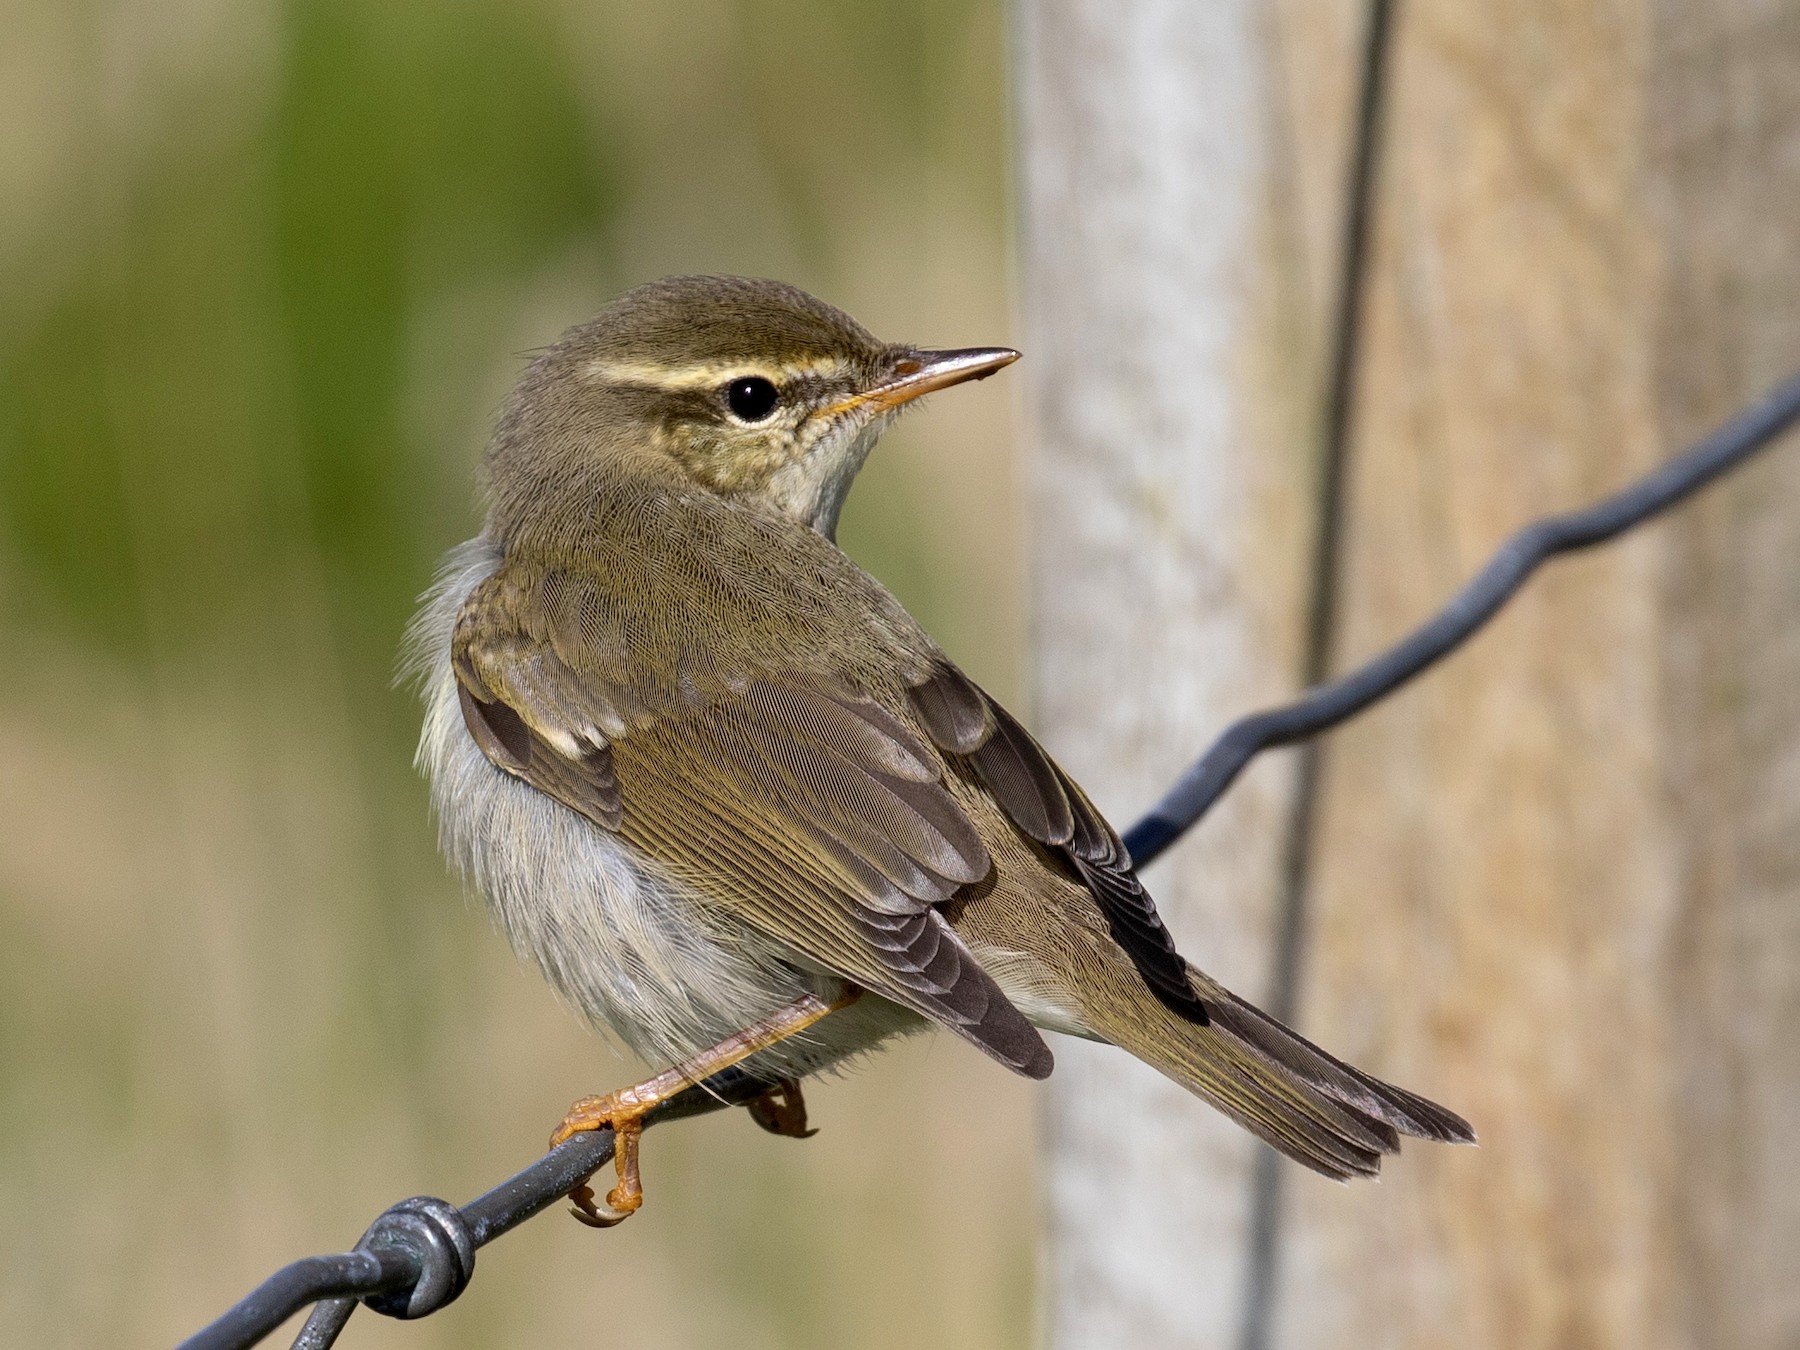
left=488, top=277, right=1019, bottom=536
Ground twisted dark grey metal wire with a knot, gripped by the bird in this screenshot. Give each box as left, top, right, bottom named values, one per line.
left=178, top=373, right=1800, bottom=1350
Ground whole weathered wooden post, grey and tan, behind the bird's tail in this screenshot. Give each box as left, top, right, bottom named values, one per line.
left=1022, top=0, right=1800, bottom=1350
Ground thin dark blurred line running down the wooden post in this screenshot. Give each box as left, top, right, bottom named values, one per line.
left=1240, top=0, right=1395, bottom=1350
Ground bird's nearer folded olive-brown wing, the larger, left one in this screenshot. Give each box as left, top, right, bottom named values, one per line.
left=452, top=567, right=1051, bottom=1078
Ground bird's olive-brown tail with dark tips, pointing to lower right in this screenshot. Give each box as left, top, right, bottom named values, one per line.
left=1089, top=967, right=1474, bottom=1181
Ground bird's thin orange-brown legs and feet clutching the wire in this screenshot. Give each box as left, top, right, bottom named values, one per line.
left=551, top=988, right=860, bottom=1228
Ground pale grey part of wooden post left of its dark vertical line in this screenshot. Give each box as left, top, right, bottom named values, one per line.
left=1019, top=0, right=1346, bottom=1350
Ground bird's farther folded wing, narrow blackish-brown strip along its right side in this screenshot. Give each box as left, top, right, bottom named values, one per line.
left=913, top=661, right=1208, bottom=1026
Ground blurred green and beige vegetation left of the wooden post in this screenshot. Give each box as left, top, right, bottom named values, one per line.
left=0, top=0, right=1035, bottom=1346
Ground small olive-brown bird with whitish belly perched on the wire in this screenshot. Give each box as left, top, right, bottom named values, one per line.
left=414, top=277, right=1474, bottom=1224
